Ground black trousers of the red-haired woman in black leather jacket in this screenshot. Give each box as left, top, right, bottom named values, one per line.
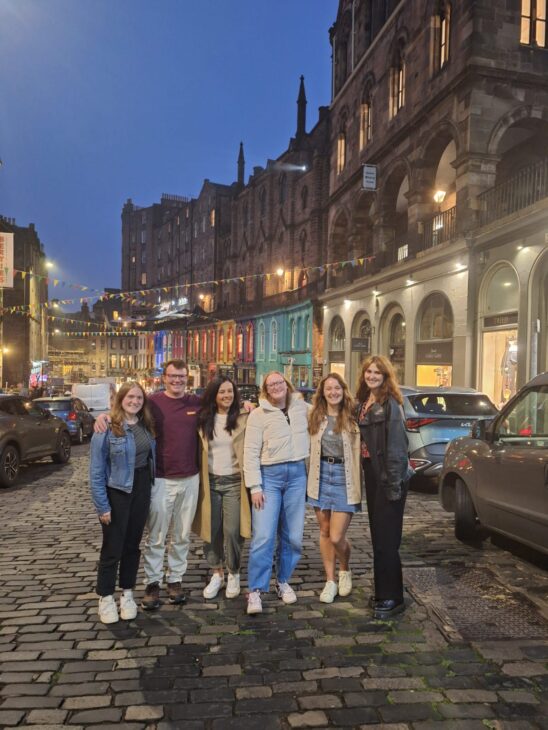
left=362, top=459, right=407, bottom=601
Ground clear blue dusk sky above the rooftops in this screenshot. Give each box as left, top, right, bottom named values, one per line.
left=0, top=0, right=338, bottom=297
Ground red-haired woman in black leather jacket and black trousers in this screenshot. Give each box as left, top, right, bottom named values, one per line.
left=357, top=355, right=412, bottom=619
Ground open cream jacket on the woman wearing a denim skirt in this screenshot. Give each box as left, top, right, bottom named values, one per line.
left=306, top=418, right=363, bottom=504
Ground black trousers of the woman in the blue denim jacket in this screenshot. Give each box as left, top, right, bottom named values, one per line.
left=96, top=466, right=151, bottom=596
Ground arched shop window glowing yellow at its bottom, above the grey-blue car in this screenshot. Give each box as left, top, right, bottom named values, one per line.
left=415, top=293, right=453, bottom=386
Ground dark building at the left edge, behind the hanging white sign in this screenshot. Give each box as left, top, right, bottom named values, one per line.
left=0, top=216, right=48, bottom=387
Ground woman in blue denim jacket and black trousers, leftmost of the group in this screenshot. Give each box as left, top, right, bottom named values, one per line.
left=89, top=382, right=155, bottom=624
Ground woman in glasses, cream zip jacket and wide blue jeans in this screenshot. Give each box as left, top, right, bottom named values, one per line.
left=244, top=371, right=310, bottom=614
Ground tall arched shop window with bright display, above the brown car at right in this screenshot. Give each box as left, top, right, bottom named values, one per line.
left=481, top=264, right=519, bottom=408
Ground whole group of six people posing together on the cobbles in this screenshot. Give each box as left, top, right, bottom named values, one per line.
left=90, top=356, right=411, bottom=623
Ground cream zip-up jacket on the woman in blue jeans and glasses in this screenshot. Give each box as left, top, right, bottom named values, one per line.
left=244, top=393, right=310, bottom=491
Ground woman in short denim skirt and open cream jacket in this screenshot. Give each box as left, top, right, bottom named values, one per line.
left=307, top=373, right=362, bottom=603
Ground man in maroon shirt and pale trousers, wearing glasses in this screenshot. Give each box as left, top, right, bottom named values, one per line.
left=141, top=360, right=200, bottom=610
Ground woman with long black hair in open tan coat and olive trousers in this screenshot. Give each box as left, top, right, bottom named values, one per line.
left=192, top=376, right=251, bottom=598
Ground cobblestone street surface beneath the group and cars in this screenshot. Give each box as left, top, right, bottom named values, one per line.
left=0, top=446, right=548, bottom=730
